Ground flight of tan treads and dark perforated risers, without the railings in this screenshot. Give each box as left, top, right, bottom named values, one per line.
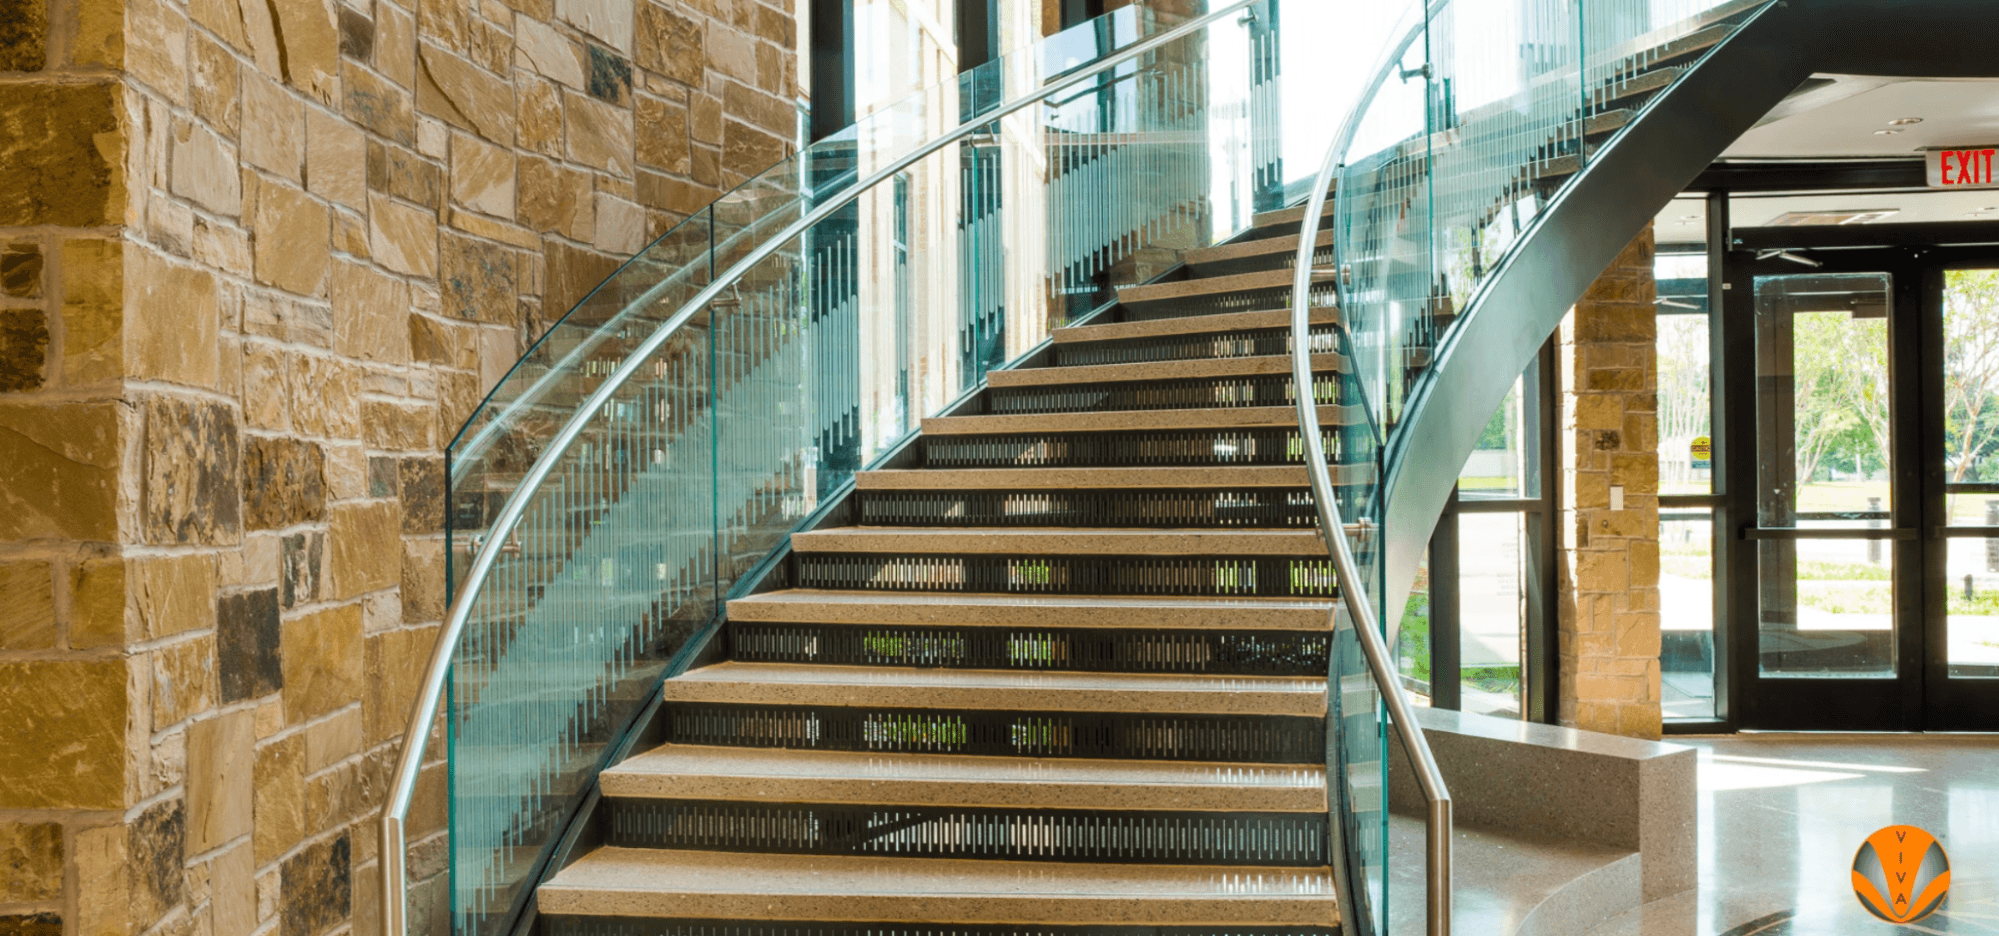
left=536, top=210, right=1371, bottom=935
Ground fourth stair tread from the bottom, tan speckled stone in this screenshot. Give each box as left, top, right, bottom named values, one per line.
left=730, top=589, right=1333, bottom=631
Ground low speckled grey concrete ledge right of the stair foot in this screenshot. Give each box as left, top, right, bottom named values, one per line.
left=1389, top=707, right=1697, bottom=901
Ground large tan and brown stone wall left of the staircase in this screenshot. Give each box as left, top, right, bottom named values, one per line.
left=0, top=0, right=796, bottom=933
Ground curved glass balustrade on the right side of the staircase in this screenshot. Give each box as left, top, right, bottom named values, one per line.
left=1293, top=0, right=1765, bottom=933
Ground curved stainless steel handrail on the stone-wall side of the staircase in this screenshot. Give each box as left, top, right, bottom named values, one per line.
left=382, top=0, right=1247, bottom=937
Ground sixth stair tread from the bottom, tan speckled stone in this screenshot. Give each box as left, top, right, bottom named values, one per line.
left=854, top=466, right=1373, bottom=491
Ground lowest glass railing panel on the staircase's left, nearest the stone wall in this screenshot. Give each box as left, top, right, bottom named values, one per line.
left=448, top=316, right=718, bottom=933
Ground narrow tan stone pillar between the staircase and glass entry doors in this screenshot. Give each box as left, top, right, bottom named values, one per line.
left=1557, top=228, right=1659, bottom=739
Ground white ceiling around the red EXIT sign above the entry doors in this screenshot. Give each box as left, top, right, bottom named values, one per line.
left=1655, top=74, right=1999, bottom=244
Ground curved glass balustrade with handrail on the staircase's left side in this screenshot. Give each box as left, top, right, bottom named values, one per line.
left=384, top=0, right=1311, bottom=933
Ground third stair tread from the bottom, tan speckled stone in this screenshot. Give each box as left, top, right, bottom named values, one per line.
left=664, top=661, right=1325, bottom=717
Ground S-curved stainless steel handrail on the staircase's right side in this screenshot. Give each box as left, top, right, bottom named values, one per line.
left=1291, top=4, right=1451, bottom=935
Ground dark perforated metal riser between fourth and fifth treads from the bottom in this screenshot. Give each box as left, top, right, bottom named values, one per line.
left=794, top=553, right=1337, bottom=597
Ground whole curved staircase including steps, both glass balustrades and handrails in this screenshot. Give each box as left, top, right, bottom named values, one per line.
left=382, top=0, right=1815, bottom=935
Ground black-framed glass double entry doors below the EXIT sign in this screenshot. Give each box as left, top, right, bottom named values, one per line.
left=1729, top=250, right=1999, bottom=731
